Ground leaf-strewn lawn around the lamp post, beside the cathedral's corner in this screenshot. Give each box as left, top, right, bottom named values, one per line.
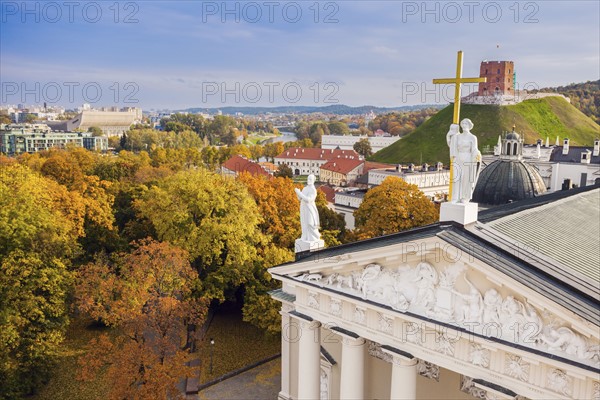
left=198, top=310, right=281, bottom=383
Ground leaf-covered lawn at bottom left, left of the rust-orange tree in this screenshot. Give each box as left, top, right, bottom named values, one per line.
left=28, top=317, right=114, bottom=400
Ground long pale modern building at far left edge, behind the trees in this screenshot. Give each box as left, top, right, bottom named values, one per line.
left=0, top=124, right=108, bottom=156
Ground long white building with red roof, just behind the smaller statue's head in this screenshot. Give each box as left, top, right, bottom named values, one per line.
left=275, top=147, right=359, bottom=176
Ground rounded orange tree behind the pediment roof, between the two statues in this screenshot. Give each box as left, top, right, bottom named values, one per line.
left=354, top=176, right=438, bottom=239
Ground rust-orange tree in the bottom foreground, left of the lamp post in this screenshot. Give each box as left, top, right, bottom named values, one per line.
left=75, top=240, right=208, bottom=399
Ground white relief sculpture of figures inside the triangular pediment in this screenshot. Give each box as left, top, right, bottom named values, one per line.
left=295, top=262, right=600, bottom=368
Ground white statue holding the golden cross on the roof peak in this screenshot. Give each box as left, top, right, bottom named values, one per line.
left=446, top=119, right=481, bottom=203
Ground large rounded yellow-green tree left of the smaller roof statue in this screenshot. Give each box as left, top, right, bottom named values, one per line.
left=134, top=169, right=261, bottom=301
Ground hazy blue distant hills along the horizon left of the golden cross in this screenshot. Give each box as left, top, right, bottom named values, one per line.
left=182, top=104, right=440, bottom=115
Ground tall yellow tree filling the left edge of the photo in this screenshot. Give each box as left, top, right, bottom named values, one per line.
left=0, top=163, right=84, bottom=398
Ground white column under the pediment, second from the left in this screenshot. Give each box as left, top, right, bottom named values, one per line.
left=298, top=320, right=321, bottom=400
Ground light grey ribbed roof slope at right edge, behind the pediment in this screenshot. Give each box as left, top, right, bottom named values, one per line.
left=488, top=189, right=600, bottom=286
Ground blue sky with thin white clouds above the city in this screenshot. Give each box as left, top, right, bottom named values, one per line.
left=0, top=0, right=600, bottom=109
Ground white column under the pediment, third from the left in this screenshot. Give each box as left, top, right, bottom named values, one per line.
left=340, top=337, right=365, bottom=400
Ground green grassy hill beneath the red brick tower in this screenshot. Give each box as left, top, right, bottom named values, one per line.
left=370, top=97, right=600, bottom=164
